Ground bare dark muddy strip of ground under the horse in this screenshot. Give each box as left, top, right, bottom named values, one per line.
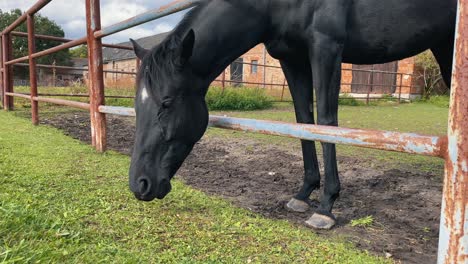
left=41, top=113, right=442, bottom=263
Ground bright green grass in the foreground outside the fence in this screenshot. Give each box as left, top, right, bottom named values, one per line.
left=0, top=111, right=389, bottom=263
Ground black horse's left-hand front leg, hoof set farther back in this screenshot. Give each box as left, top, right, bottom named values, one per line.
left=281, top=59, right=320, bottom=212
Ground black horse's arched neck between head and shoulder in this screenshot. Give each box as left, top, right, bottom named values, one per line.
left=186, top=0, right=266, bottom=82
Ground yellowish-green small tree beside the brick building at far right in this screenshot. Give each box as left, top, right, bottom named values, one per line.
left=416, top=50, right=448, bottom=99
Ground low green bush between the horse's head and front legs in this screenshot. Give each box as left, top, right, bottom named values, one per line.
left=206, top=87, right=273, bottom=110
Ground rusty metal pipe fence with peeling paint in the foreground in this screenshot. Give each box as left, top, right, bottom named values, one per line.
left=0, top=0, right=468, bottom=263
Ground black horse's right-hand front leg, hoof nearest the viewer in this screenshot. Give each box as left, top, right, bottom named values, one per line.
left=306, top=33, right=343, bottom=229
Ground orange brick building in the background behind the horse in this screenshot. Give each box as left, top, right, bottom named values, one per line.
left=103, top=33, right=421, bottom=98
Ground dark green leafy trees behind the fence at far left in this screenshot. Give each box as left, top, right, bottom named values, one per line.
left=0, top=9, right=71, bottom=73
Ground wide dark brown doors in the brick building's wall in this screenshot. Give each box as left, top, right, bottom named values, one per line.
left=351, top=61, right=398, bottom=94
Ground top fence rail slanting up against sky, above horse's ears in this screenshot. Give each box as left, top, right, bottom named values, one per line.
left=94, top=0, right=201, bottom=38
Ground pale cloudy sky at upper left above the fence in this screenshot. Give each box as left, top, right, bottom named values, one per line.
left=0, top=0, right=185, bottom=43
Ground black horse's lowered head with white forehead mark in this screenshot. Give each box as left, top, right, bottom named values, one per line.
left=129, top=30, right=208, bottom=201
